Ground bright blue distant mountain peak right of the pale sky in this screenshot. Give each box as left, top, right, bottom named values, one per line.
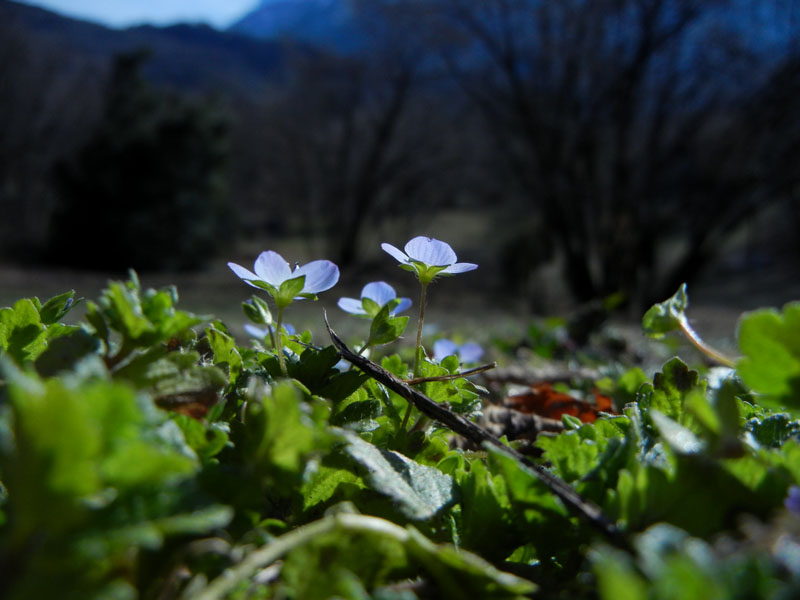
left=228, top=0, right=363, bottom=51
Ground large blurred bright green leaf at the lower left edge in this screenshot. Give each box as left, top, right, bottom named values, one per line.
left=0, top=364, right=199, bottom=545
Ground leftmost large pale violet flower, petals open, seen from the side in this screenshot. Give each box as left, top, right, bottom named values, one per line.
left=228, top=250, right=339, bottom=305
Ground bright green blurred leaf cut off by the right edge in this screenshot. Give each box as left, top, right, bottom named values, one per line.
left=736, top=302, right=800, bottom=409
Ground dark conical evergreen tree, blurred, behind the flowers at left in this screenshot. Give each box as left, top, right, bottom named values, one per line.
left=45, top=52, right=233, bottom=269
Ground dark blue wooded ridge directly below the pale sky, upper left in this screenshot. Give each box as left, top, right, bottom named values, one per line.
left=0, top=0, right=285, bottom=95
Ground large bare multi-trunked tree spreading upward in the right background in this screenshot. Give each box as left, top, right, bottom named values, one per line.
left=416, top=0, right=796, bottom=302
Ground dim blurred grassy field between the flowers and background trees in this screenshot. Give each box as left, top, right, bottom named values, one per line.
left=0, top=209, right=800, bottom=366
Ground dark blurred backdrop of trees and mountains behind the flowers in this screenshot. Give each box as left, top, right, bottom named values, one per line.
left=0, top=0, right=800, bottom=309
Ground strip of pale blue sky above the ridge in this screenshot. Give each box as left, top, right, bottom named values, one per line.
left=16, top=0, right=258, bottom=27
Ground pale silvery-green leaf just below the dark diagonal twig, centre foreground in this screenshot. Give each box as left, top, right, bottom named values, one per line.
left=343, top=431, right=456, bottom=521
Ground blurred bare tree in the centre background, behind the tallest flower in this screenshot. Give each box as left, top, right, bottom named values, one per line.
left=241, top=2, right=472, bottom=265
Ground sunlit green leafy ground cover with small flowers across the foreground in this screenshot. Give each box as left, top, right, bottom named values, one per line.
left=0, top=246, right=800, bottom=600
